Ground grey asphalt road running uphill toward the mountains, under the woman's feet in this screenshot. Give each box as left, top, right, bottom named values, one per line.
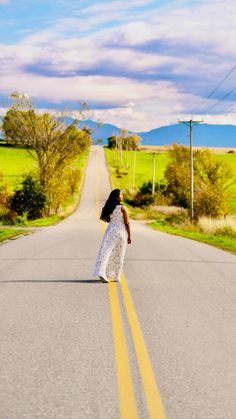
left=0, top=147, right=236, bottom=419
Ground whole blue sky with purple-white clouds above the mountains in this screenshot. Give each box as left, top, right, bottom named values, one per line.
left=0, top=0, right=236, bottom=132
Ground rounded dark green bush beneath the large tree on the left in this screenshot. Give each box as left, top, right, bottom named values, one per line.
left=10, top=175, right=46, bottom=220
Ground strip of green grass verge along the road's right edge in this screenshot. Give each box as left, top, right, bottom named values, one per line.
left=149, top=221, right=236, bottom=253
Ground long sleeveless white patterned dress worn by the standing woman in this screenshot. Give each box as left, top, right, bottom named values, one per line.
left=93, top=205, right=128, bottom=281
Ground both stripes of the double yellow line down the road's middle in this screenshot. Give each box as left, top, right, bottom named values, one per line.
left=96, top=152, right=166, bottom=419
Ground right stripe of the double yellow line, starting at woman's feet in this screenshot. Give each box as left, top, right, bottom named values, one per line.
left=121, top=274, right=166, bottom=419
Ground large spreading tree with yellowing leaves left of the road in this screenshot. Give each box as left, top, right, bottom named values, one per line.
left=2, top=93, right=91, bottom=215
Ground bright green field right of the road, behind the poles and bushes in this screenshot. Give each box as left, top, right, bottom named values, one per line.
left=105, top=148, right=236, bottom=214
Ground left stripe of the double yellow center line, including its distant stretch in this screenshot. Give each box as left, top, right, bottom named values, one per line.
left=96, top=152, right=138, bottom=419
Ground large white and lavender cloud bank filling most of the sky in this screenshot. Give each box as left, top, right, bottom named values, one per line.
left=0, top=0, right=236, bottom=130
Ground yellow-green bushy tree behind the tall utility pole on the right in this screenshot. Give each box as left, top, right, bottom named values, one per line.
left=165, top=144, right=232, bottom=218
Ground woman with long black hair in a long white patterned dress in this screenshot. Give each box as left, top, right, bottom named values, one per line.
left=94, top=189, right=131, bottom=282
